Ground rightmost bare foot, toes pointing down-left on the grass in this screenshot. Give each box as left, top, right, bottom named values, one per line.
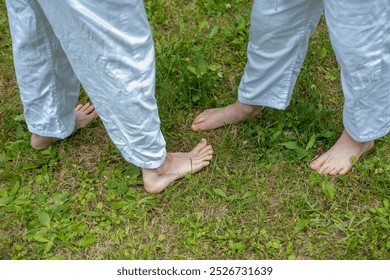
left=309, top=129, right=374, bottom=176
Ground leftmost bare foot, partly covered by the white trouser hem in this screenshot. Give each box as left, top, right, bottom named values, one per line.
left=30, top=103, right=99, bottom=150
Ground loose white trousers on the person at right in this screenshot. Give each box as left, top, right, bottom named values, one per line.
left=238, top=0, right=390, bottom=142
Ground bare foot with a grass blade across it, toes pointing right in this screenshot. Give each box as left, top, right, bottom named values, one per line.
left=142, top=139, right=213, bottom=193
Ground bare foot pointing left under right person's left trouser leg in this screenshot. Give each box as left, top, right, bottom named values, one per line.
left=191, top=102, right=261, bottom=130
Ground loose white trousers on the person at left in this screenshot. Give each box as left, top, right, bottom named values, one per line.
left=7, top=0, right=166, bottom=168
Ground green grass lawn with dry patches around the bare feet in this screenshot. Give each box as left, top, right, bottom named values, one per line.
left=0, top=0, right=390, bottom=259
